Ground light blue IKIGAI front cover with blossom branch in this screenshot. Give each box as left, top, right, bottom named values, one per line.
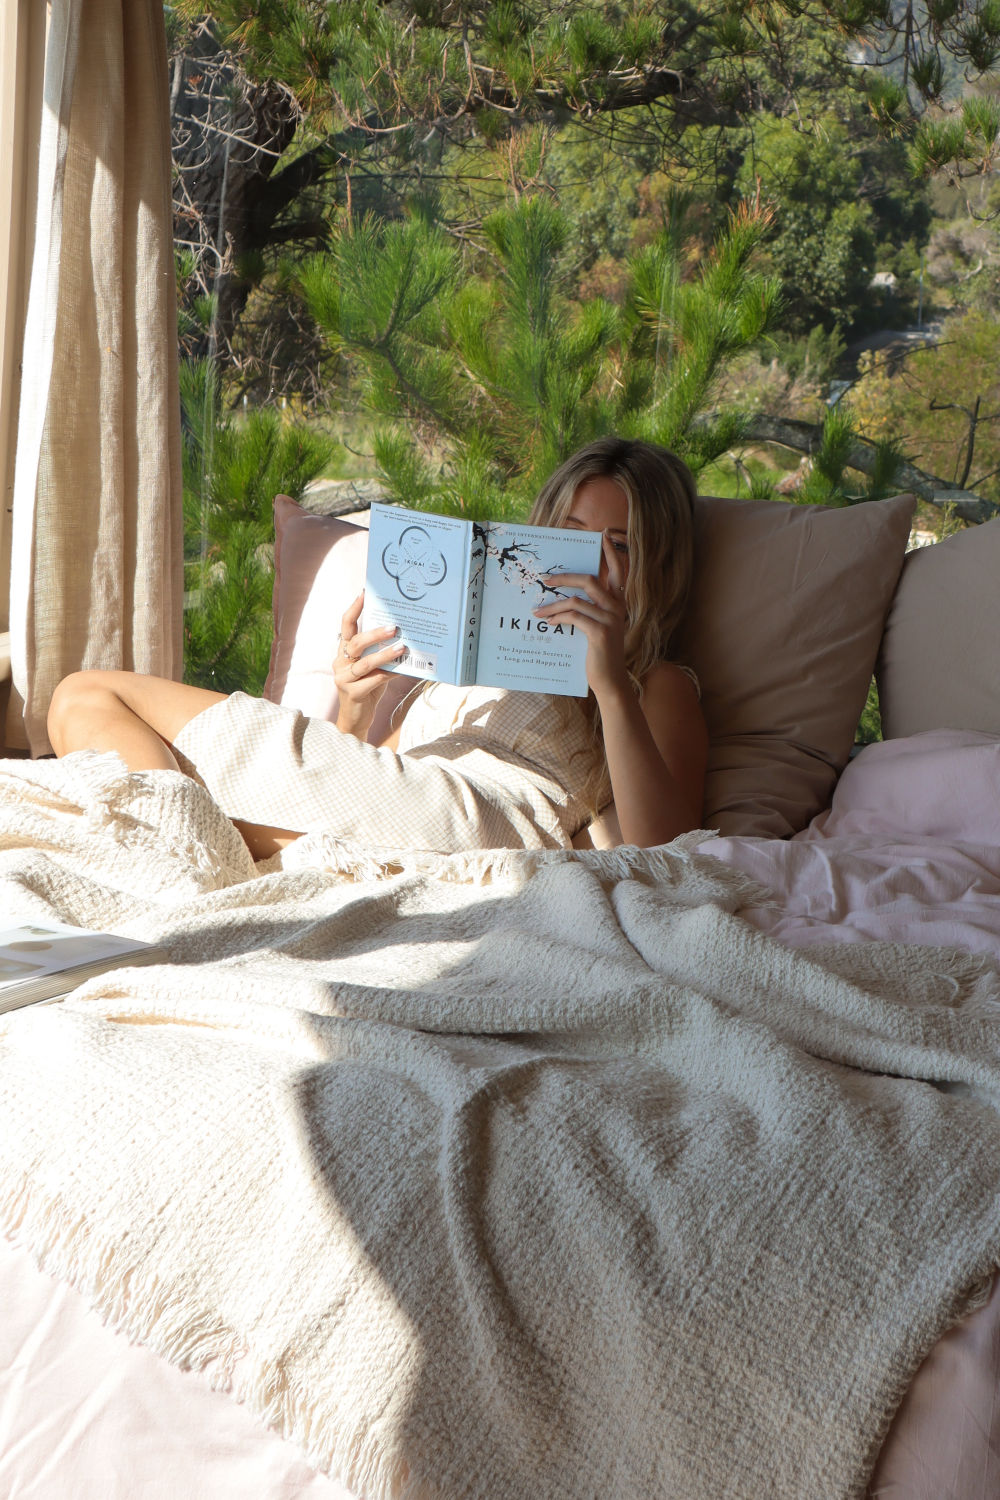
left=475, top=522, right=601, bottom=698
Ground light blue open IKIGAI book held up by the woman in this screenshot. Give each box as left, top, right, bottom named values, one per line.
left=360, top=504, right=601, bottom=698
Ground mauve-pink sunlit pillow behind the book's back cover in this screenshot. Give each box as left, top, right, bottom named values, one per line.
left=264, top=495, right=417, bottom=744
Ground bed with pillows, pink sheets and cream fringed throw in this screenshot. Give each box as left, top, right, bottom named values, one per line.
left=0, top=498, right=1000, bottom=1500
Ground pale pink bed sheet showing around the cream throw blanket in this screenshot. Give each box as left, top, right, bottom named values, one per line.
left=0, top=734, right=1000, bottom=1500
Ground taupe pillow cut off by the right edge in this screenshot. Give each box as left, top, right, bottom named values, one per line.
left=876, top=519, right=1000, bottom=740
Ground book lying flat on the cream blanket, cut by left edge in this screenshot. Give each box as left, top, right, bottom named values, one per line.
left=0, top=923, right=166, bottom=1014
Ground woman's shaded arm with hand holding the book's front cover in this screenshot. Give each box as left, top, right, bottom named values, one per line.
left=535, top=536, right=708, bottom=848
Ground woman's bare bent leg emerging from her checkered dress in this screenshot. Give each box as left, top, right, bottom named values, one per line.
left=48, top=672, right=301, bottom=860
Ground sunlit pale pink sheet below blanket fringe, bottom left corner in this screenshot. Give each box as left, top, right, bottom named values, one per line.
left=0, top=1236, right=354, bottom=1500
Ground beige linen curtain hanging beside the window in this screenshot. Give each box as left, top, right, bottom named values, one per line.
left=4, top=0, right=183, bottom=755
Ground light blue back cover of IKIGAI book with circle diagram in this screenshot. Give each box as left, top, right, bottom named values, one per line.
left=361, top=504, right=472, bottom=683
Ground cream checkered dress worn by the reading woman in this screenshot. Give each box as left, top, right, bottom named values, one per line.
left=175, top=684, right=603, bottom=852
